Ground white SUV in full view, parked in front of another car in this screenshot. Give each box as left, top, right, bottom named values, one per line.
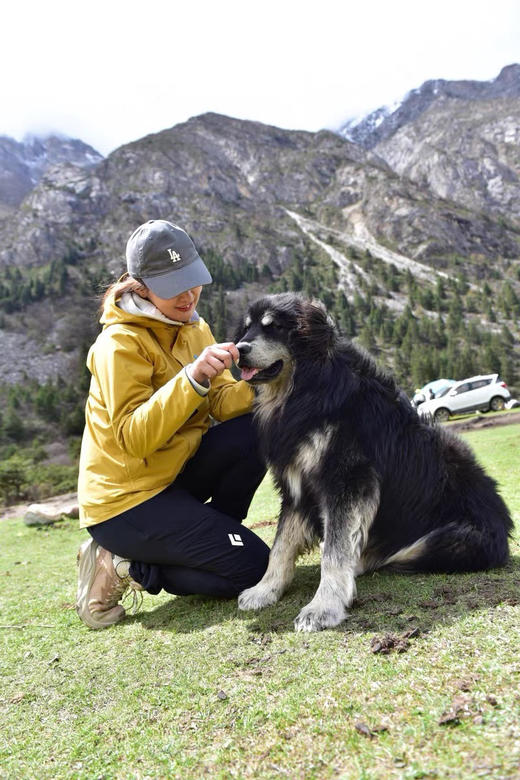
left=417, top=374, right=511, bottom=422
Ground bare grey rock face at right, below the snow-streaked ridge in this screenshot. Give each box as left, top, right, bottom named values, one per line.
left=374, top=97, right=520, bottom=229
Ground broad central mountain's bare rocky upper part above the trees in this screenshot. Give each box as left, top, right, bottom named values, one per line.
left=0, top=109, right=518, bottom=276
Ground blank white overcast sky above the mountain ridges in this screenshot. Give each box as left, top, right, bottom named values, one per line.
left=0, top=0, right=520, bottom=154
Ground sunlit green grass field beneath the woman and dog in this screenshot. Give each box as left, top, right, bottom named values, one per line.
left=0, top=425, right=520, bottom=780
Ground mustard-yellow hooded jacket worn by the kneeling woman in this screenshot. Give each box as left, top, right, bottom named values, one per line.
left=78, top=297, right=253, bottom=528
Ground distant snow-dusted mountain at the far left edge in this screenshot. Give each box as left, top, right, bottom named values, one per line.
left=0, top=135, right=102, bottom=216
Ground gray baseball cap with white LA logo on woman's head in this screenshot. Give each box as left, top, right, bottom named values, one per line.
left=126, top=219, right=213, bottom=298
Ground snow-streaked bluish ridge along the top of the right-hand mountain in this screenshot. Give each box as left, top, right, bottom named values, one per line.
left=338, top=63, right=520, bottom=149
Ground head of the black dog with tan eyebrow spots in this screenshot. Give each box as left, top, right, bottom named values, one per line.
left=235, top=293, right=335, bottom=385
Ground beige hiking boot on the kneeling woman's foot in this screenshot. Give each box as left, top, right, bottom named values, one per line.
left=76, top=538, right=143, bottom=628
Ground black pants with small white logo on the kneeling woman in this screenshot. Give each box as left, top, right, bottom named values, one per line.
left=88, top=414, right=269, bottom=598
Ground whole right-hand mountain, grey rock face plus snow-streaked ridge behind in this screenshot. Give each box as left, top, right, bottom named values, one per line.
left=341, top=65, right=520, bottom=228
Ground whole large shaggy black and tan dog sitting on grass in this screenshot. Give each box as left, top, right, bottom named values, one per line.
left=237, top=293, right=512, bottom=631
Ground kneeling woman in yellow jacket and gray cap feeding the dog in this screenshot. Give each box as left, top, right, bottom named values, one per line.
left=77, top=220, right=269, bottom=628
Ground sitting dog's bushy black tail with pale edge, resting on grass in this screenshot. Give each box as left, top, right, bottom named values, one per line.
left=381, top=523, right=509, bottom=573
